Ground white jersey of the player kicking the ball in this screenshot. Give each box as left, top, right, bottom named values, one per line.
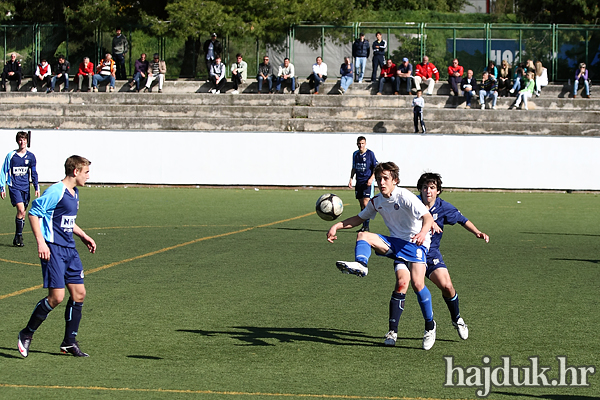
left=358, top=187, right=431, bottom=249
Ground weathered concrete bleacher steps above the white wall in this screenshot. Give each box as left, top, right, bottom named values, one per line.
left=0, top=81, right=600, bottom=136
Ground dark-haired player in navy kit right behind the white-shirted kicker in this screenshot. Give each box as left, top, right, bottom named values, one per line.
left=417, top=172, right=490, bottom=340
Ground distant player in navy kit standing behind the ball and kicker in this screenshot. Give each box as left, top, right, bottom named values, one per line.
left=348, top=136, right=377, bottom=232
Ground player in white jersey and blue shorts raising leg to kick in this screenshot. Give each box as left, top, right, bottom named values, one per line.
left=327, top=162, right=436, bottom=350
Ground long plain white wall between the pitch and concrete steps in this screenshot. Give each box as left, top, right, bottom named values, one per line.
left=0, top=130, right=600, bottom=190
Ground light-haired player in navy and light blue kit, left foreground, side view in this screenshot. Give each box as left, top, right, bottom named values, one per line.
left=18, top=156, right=96, bottom=357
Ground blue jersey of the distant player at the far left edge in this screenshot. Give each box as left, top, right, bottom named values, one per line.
left=0, top=150, right=40, bottom=192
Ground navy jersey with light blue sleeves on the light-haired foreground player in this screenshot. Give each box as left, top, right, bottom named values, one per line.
left=29, top=182, right=79, bottom=247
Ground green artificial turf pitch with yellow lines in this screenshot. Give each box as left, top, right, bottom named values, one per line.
left=0, top=187, right=600, bottom=400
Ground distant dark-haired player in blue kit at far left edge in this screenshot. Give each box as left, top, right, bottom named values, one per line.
left=0, top=131, right=40, bottom=247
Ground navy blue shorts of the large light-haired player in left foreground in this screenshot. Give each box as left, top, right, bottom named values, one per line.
left=41, top=242, right=83, bottom=289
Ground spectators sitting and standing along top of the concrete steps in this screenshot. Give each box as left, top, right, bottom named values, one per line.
left=2, top=28, right=591, bottom=102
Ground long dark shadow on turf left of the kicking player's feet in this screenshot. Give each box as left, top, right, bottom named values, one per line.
left=177, top=326, right=432, bottom=349
